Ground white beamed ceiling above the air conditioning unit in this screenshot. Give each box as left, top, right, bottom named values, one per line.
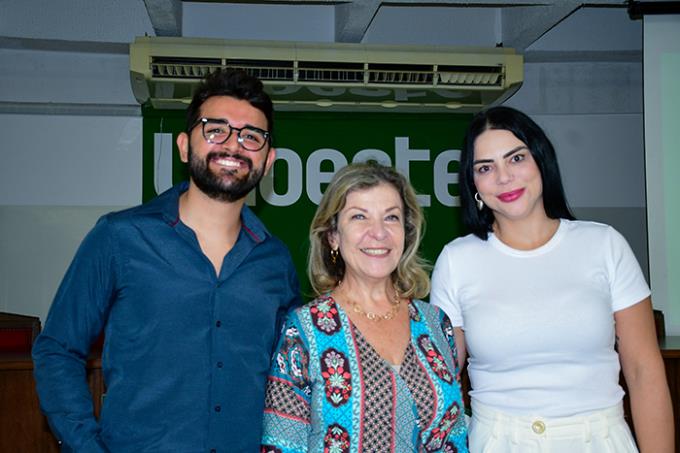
left=0, top=0, right=641, bottom=53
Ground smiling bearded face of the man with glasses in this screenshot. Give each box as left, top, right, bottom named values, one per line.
left=177, top=96, right=276, bottom=202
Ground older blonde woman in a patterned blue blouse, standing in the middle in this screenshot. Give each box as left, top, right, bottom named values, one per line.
left=262, top=163, right=467, bottom=452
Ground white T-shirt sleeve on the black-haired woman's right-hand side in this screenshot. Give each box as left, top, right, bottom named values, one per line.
left=608, top=227, right=650, bottom=311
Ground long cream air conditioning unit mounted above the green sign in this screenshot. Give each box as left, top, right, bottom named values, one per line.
left=130, top=37, right=524, bottom=111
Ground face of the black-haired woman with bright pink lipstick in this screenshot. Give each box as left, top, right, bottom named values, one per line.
left=473, top=129, right=546, bottom=226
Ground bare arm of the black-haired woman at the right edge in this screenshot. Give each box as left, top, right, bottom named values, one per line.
left=614, top=297, right=675, bottom=453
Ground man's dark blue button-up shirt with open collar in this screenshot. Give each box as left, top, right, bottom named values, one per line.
left=33, top=183, right=300, bottom=453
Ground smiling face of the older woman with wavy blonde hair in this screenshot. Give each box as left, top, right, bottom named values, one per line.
left=329, top=183, right=405, bottom=281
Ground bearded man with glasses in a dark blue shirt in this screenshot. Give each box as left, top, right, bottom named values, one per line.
left=33, top=71, right=299, bottom=453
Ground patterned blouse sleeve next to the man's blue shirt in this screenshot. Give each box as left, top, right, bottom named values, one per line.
left=260, top=312, right=311, bottom=453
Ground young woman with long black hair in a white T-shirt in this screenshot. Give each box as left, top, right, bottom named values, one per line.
left=430, top=107, right=674, bottom=453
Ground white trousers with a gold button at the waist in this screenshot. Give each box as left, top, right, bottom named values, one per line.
left=468, top=401, right=638, bottom=453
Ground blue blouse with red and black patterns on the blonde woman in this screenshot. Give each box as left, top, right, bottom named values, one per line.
left=261, top=296, right=468, bottom=453
